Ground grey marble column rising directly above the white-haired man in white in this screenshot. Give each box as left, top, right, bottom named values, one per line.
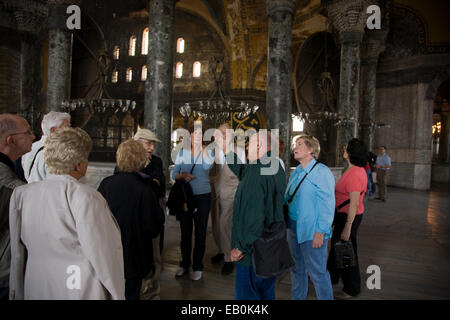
left=47, top=0, right=74, bottom=111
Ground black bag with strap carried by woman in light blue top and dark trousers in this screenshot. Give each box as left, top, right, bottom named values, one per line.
left=166, top=155, right=200, bottom=216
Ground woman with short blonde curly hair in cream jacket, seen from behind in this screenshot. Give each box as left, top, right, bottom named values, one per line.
left=10, top=128, right=125, bottom=300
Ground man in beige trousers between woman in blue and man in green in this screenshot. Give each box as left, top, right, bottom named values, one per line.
left=211, top=123, right=246, bottom=275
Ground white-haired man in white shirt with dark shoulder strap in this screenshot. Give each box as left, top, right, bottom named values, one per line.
left=22, top=111, right=70, bottom=183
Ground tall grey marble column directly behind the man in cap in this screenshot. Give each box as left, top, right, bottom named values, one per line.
left=144, top=0, right=177, bottom=178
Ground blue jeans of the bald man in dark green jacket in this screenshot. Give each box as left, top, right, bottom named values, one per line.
left=234, top=264, right=276, bottom=300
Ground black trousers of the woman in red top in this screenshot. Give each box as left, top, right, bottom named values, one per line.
left=327, top=212, right=362, bottom=296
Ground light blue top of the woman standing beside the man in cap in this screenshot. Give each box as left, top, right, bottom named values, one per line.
left=172, top=149, right=214, bottom=195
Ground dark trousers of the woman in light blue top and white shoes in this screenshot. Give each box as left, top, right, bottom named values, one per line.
left=179, top=193, right=211, bottom=271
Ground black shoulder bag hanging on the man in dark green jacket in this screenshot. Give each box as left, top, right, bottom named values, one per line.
left=252, top=176, right=295, bottom=279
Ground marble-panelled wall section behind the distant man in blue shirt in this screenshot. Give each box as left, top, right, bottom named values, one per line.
left=375, top=72, right=442, bottom=190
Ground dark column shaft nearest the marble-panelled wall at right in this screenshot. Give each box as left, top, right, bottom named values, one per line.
left=360, top=30, right=387, bottom=153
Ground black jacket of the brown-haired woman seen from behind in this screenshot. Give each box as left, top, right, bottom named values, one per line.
left=98, top=172, right=164, bottom=279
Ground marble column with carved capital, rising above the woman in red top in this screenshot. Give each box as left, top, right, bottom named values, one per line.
left=323, top=0, right=373, bottom=165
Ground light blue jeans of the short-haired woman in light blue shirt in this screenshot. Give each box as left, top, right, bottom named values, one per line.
left=287, top=219, right=333, bottom=300
